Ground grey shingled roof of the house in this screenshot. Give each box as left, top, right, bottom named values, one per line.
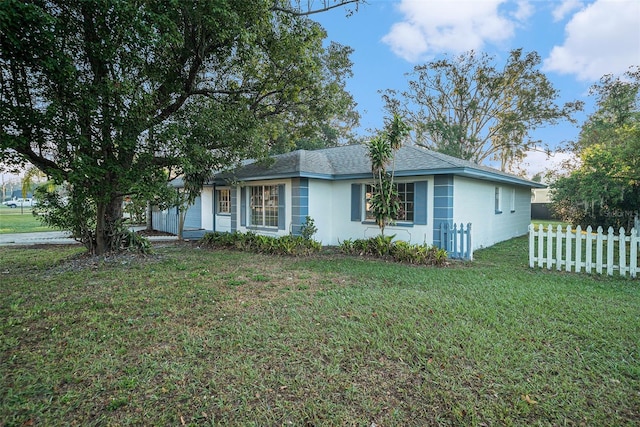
left=214, top=145, right=545, bottom=188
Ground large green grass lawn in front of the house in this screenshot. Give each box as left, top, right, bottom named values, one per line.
left=0, top=238, right=640, bottom=427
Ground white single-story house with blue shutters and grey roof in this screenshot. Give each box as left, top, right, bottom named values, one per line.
left=153, top=145, right=544, bottom=256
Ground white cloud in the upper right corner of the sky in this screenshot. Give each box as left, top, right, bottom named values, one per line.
left=543, top=0, right=640, bottom=81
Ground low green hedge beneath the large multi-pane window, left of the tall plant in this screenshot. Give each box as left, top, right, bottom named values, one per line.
left=199, top=231, right=322, bottom=256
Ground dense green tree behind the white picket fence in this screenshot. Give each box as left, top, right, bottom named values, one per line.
left=551, top=67, right=640, bottom=230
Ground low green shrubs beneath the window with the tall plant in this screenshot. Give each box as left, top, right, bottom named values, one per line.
left=340, top=235, right=447, bottom=266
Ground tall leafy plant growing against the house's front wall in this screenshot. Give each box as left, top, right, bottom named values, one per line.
left=368, top=114, right=410, bottom=235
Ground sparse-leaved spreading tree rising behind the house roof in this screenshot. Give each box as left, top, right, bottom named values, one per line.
left=384, top=49, right=582, bottom=170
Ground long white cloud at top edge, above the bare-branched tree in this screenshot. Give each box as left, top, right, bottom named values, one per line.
left=382, top=0, right=532, bottom=62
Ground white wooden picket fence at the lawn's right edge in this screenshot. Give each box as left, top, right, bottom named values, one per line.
left=529, top=224, right=640, bottom=278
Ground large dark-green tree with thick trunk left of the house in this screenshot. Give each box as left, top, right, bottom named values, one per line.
left=0, top=0, right=358, bottom=254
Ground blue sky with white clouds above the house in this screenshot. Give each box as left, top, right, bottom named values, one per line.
left=313, top=0, right=640, bottom=176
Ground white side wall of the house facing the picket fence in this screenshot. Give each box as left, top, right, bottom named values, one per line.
left=453, top=176, right=531, bottom=250
